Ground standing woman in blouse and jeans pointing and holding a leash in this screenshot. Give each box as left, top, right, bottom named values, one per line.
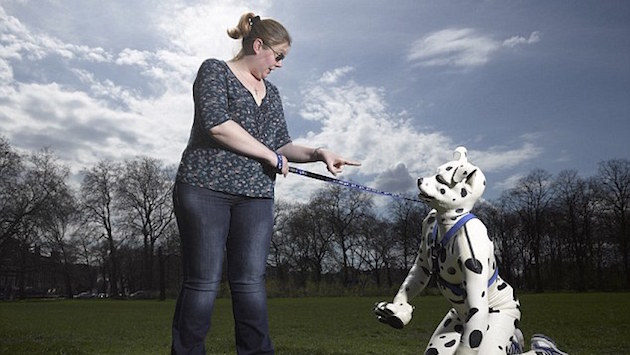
left=172, top=13, right=360, bottom=354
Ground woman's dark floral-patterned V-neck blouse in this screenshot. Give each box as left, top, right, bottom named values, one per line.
left=176, top=59, right=291, bottom=198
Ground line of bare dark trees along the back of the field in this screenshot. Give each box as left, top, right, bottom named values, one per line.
left=0, top=137, right=630, bottom=299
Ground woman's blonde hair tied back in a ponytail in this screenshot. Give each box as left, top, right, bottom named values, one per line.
left=227, top=12, right=291, bottom=60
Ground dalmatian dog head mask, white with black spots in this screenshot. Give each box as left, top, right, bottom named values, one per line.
left=418, top=147, right=486, bottom=219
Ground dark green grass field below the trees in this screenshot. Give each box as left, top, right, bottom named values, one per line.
left=0, top=293, right=630, bottom=355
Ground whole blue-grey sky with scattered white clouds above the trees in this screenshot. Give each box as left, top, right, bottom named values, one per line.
left=0, top=0, right=630, bottom=204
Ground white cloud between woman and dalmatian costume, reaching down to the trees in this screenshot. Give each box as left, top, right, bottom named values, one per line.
left=278, top=70, right=453, bottom=200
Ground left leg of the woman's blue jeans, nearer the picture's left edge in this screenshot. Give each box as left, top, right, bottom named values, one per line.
left=171, top=184, right=230, bottom=354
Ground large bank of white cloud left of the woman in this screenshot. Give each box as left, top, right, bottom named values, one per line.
left=0, top=2, right=184, bottom=172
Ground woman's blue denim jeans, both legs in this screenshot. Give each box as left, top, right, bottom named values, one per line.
left=171, top=184, right=274, bottom=355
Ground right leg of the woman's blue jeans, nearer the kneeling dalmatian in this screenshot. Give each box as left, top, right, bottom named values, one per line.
left=227, top=199, right=274, bottom=355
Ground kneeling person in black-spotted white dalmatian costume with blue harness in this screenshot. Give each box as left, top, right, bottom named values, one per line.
left=374, top=147, right=566, bottom=355
